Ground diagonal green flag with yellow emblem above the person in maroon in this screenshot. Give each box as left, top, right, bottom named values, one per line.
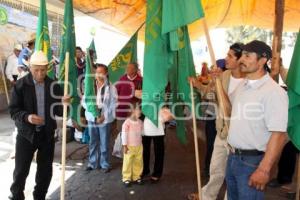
left=108, top=30, right=139, bottom=83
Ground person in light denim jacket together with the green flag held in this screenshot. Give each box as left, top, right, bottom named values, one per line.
left=82, top=57, right=117, bottom=173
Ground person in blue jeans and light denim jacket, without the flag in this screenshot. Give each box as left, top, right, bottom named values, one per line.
left=82, top=64, right=117, bottom=173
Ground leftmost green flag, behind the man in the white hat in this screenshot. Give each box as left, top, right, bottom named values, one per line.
left=35, top=0, right=55, bottom=79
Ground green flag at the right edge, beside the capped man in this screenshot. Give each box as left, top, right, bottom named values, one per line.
left=286, top=30, right=300, bottom=149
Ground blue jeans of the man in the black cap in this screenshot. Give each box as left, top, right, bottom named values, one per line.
left=226, top=154, right=264, bottom=200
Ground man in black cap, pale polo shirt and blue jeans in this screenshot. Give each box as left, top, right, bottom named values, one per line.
left=226, top=40, right=288, bottom=200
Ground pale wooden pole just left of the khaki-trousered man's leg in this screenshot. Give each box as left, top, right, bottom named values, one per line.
left=190, top=83, right=202, bottom=200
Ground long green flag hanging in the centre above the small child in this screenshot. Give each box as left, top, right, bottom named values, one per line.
left=142, top=0, right=174, bottom=128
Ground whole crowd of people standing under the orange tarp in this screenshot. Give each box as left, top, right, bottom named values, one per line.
left=5, top=33, right=297, bottom=200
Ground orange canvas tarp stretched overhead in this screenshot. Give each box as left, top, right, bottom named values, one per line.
left=69, top=0, right=300, bottom=39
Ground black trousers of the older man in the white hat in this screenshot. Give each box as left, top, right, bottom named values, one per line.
left=10, top=132, right=54, bottom=200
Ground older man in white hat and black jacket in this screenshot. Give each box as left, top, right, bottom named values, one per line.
left=9, top=51, right=70, bottom=200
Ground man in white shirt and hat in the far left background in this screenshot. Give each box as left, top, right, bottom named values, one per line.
left=5, top=44, right=22, bottom=85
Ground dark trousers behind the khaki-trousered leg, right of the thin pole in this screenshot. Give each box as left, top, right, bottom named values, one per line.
left=205, top=119, right=217, bottom=171
